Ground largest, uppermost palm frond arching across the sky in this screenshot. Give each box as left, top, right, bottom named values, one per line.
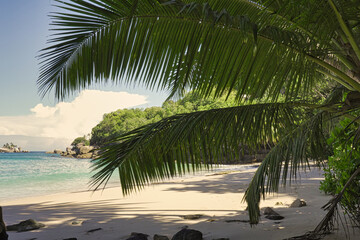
left=38, top=0, right=360, bottom=100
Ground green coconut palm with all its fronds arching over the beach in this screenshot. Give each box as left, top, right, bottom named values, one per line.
left=38, top=0, right=360, bottom=236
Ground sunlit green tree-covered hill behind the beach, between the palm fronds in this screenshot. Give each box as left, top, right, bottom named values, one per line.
left=90, top=93, right=236, bottom=146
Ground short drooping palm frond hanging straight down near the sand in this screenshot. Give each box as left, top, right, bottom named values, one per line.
left=244, top=107, right=330, bottom=224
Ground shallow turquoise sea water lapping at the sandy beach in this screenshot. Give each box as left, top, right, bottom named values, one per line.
left=0, top=152, right=256, bottom=201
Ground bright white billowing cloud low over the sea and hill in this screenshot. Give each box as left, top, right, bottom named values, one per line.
left=0, top=90, right=147, bottom=148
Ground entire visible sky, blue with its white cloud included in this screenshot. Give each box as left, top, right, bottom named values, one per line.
left=0, top=0, right=166, bottom=150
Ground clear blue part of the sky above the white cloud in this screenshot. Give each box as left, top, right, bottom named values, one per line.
left=0, top=0, right=166, bottom=116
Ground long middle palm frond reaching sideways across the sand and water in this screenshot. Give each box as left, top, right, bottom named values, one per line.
left=92, top=103, right=312, bottom=194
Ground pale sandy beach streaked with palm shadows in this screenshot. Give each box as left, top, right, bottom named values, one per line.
left=0, top=165, right=356, bottom=240
